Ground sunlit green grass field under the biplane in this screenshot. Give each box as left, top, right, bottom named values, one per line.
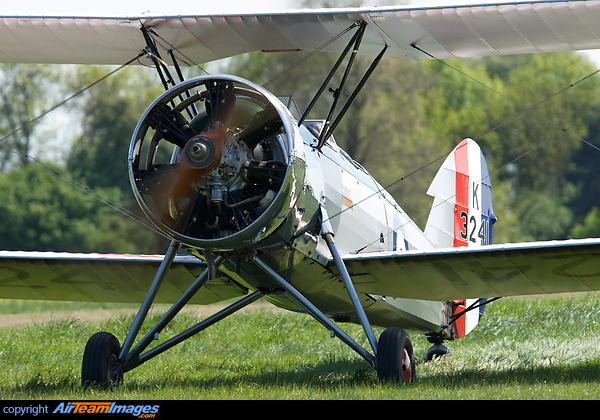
left=0, top=294, right=600, bottom=400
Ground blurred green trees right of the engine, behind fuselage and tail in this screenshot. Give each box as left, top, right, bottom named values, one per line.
left=232, top=49, right=600, bottom=242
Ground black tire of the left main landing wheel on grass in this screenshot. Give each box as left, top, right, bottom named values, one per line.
left=81, top=332, right=123, bottom=389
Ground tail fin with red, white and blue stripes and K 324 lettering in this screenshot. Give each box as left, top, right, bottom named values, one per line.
left=425, top=139, right=496, bottom=338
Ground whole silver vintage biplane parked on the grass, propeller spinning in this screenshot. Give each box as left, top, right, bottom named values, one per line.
left=0, top=0, right=600, bottom=387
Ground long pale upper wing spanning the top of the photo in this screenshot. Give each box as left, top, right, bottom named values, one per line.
left=0, top=0, right=600, bottom=65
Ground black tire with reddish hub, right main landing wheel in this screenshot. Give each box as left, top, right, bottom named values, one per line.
left=376, top=327, right=417, bottom=384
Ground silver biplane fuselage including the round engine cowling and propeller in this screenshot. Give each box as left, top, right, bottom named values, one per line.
left=129, top=75, right=446, bottom=331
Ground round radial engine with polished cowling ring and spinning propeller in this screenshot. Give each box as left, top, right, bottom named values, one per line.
left=129, top=76, right=305, bottom=250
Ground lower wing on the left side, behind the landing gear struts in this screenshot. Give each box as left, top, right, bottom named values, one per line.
left=0, top=251, right=247, bottom=305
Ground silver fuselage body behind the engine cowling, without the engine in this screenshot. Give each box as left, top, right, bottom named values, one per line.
left=213, top=116, right=446, bottom=332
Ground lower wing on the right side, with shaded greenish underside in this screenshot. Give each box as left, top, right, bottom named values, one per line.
left=338, top=239, right=600, bottom=301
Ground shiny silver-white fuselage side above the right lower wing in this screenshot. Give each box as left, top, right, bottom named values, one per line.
left=300, top=122, right=434, bottom=254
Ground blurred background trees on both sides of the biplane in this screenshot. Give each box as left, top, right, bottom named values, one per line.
left=0, top=47, right=600, bottom=253
